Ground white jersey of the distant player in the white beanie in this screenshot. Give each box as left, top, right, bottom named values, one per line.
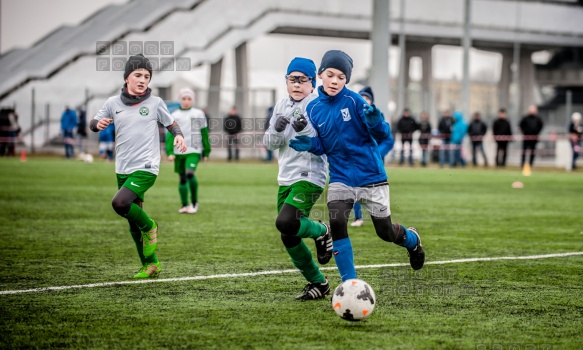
left=172, top=108, right=208, bottom=154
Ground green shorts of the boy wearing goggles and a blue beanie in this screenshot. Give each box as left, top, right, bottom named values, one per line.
left=277, top=181, right=324, bottom=217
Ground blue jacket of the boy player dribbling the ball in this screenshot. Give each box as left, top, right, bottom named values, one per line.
left=303, top=86, right=392, bottom=187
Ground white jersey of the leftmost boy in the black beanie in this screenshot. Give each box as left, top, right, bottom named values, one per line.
left=95, top=95, right=174, bottom=175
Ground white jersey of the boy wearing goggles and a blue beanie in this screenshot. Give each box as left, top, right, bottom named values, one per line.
left=263, top=93, right=327, bottom=187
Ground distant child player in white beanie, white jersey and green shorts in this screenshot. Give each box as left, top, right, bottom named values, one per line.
left=166, top=88, right=211, bottom=214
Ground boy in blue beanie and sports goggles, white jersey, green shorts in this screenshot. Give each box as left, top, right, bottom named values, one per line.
left=263, top=57, right=332, bottom=300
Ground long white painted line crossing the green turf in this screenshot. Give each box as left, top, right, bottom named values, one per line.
left=0, top=252, right=583, bottom=295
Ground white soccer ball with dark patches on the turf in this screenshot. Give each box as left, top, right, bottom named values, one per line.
left=332, top=279, right=376, bottom=321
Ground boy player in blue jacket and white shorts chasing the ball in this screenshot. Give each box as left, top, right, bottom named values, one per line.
left=289, top=50, right=425, bottom=281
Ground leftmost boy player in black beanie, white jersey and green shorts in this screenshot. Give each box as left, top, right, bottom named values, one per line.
left=89, top=54, right=186, bottom=278
